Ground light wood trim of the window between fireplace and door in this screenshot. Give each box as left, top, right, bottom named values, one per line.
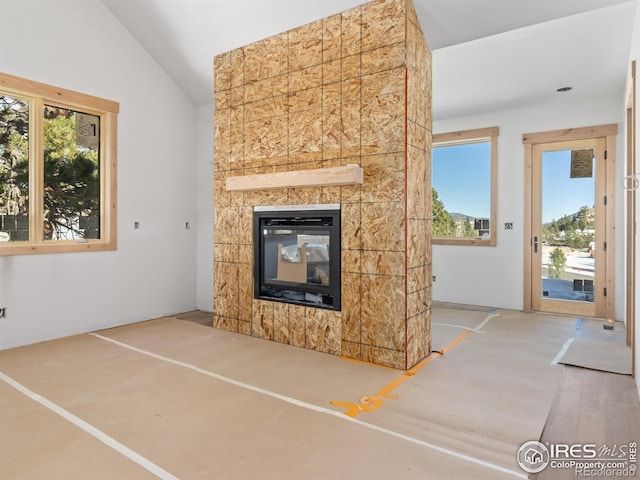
left=431, top=127, right=500, bottom=247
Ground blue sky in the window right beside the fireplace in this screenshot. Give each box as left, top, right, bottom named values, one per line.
left=431, top=142, right=491, bottom=218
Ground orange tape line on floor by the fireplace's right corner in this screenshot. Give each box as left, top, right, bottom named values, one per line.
left=329, top=313, right=498, bottom=417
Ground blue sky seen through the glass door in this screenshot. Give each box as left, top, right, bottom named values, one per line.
left=542, top=150, right=595, bottom=223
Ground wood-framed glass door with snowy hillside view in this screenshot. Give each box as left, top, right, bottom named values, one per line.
left=531, top=139, right=606, bottom=317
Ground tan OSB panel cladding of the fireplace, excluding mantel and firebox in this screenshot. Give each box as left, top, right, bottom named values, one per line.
left=214, top=0, right=431, bottom=368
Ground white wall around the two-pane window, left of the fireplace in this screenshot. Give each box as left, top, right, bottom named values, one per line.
left=0, top=0, right=197, bottom=348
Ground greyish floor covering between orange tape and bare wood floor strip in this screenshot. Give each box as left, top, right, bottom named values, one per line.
left=367, top=310, right=575, bottom=470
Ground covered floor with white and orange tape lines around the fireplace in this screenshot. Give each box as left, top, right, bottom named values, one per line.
left=0, top=304, right=640, bottom=480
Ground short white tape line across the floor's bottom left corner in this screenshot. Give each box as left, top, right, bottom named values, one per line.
left=0, top=372, right=179, bottom=480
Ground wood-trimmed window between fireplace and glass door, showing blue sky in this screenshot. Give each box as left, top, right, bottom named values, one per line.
left=431, top=127, right=498, bottom=246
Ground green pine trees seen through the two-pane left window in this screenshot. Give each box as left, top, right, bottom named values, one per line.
left=0, top=95, right=100, bottom=240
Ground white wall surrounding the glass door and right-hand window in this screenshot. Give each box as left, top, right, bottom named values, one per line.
left=433, top=94, right=624, bottom=319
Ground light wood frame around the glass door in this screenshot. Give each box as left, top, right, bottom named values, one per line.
left=522, top=123, right=618, bottom=319
